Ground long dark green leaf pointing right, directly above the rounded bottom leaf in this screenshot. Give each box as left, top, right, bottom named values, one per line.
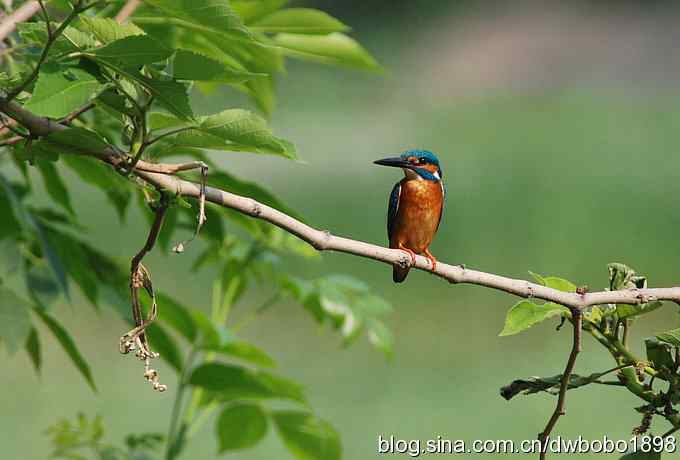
left=189, top=363, right=305, bottom=403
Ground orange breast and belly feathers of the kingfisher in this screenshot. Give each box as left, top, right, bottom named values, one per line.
left=390, top=179, right=444, bottom=254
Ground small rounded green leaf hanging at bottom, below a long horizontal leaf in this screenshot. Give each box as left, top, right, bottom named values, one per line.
left=216, top=404, right=268, bottom=454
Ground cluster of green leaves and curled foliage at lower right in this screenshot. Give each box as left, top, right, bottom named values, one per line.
left=500, top=263, right=680, bottom=448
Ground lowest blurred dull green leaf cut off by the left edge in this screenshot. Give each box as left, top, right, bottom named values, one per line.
left=0, top=286, right=31, bottom=354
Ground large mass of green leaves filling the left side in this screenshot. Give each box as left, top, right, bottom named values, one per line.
left=0, top=0, right=382, bottom=460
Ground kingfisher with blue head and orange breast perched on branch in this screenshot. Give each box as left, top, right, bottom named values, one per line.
left=373, top=150, right=446, bottom=283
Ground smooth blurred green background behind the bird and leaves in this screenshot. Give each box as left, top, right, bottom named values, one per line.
left=0, top=0, right=680, bottom=460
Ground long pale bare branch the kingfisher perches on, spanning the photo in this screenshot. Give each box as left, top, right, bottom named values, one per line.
left=0, top=99, right=680, bottom=310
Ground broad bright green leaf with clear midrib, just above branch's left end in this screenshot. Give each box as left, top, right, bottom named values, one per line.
left=25, top=63, right=102, bottom=118
